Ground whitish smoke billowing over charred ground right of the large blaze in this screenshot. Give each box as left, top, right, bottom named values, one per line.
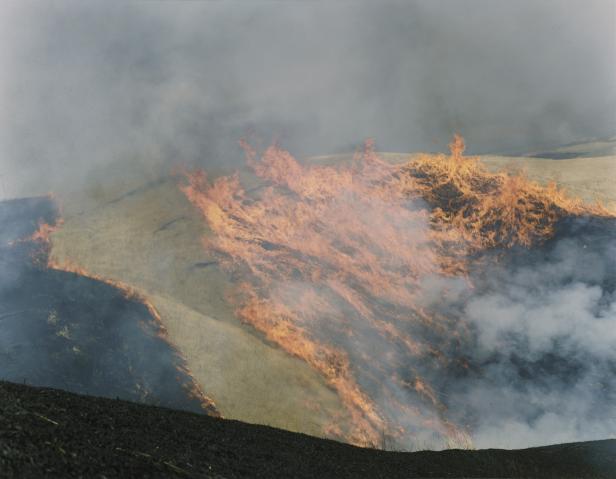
left=440, top=219, right=616, bottom=448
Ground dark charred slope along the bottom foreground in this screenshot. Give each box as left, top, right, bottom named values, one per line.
left=0, top=382, right=616, bottom=479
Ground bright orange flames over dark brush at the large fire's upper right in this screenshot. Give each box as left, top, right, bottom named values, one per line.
left=403, top=135, right=613, bottom=250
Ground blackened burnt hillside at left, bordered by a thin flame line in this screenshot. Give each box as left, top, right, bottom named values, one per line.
left=0, top=198, right=215, bottom=413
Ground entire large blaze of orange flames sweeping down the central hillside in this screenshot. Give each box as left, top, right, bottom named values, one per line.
left=181, top=135, right=610, bottom=445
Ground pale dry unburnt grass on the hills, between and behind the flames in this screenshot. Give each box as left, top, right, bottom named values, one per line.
left=44, top=140, right=616, bottom=435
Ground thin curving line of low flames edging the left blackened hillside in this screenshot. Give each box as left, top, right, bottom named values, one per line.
left=29, top=218, right=219, bottom=416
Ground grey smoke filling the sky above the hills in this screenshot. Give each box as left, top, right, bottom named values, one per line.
left=0, top=0, right=616, bottom=196
